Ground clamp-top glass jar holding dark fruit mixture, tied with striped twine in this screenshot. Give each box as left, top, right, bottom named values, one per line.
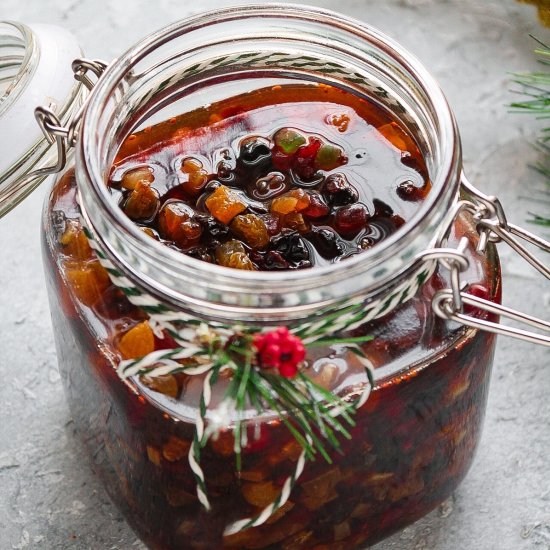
left=3, top=5, right=550, bottom=549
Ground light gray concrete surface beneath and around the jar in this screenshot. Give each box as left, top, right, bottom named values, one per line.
left=0, top=0, right=550, bottom=550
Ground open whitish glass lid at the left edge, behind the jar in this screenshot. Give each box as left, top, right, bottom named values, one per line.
left=0, top=21, right=85, bottom=217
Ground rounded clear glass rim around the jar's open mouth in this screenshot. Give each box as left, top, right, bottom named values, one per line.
left=77, top=3, right=461, bottom=320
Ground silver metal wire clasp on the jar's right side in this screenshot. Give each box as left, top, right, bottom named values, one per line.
left=419, top=177, right=550, bottom=347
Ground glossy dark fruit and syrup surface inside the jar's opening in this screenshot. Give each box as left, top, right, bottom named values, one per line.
left=110, top=85, right=430, bottom=270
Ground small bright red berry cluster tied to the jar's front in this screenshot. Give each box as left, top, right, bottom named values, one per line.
left=254, top=327, right=306, bottom=378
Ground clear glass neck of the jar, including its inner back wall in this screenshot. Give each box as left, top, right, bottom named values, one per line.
left=77, top=5, right=461, bottom=322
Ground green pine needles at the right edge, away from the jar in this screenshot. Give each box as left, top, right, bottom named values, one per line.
left=510, top=35, right=550, bottom=227
